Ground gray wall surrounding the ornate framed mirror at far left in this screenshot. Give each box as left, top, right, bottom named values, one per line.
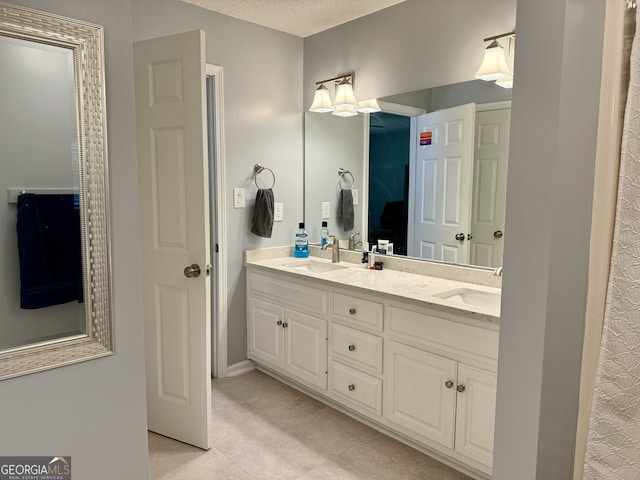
left=0, top=0, right=147, bottom=480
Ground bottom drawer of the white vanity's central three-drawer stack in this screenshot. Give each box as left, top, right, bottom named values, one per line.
left=331, top=362, right=382, bottom=415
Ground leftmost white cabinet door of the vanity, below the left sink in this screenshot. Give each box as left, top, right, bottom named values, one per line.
left=247, top=298, right=284, bottom=368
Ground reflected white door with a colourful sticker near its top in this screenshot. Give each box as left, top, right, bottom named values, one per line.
left=409, top=103, right=475, bottom=263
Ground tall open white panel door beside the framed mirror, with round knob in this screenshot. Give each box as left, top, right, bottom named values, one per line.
left=134, top=31, right=211, bottom=449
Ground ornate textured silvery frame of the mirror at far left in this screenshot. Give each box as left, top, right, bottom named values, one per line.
left=0, top=2, right=113, bottom=380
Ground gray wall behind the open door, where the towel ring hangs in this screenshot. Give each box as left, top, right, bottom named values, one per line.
left=133, top=0, right=303, bottom=364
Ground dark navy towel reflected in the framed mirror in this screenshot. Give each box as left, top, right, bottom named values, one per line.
left=17, top=193, right=82, bottom=309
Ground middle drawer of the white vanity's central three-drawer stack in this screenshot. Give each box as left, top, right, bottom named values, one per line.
left=331, top=323, right=382, bottom=373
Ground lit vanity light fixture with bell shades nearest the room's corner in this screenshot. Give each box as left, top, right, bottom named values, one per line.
left=309, top=73, right=380, bottom=117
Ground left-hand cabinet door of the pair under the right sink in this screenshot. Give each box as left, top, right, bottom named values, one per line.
left=385, top=341, right=457, bottom=448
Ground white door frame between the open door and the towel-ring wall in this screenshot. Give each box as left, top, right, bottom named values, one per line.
left=206, top=63, right=228, bottom=378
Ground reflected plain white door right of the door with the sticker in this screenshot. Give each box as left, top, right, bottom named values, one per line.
left=471, top=108, right=511, bottom=267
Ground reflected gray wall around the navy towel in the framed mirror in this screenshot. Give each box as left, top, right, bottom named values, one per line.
left=0, top=33, right=85, bottom=350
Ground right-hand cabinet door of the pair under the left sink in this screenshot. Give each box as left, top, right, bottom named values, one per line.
left=283, top=310, right=327, bottom=390
